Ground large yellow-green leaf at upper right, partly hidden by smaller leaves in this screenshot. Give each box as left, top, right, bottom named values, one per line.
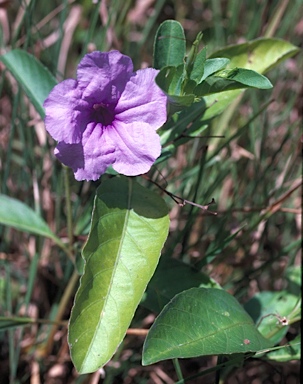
left=203, top=38, right=299, bottom=120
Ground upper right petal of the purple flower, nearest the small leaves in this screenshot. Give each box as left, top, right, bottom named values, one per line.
left=115, top=68, right=167, bottom=129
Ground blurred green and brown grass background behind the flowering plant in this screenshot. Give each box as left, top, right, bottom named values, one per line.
left=0, top=0, right=303, bottom=384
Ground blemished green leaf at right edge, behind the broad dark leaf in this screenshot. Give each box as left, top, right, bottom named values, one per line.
left=244, top=291, right=298, bottom=344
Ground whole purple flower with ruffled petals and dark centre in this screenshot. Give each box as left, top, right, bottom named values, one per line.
left=44, top=51, right=167, bottom=180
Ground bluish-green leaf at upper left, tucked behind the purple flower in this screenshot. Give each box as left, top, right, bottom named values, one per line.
left=0, top=49, right=57, bottom=119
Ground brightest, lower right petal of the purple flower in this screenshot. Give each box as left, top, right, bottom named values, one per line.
left=104, top=122, right=161, bottom=176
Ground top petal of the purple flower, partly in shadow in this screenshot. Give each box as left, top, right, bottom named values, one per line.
left=77, top=51, right=133, bottom=103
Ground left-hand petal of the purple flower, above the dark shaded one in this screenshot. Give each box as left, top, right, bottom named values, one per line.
left=43, top=79, right=88, bottom=144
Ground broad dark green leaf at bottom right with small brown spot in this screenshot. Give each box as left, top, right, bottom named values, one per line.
left=142, top=288, right=271, bottom=365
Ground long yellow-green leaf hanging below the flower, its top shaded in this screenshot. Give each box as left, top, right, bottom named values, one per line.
left=68, top=177, right=169, bottom=373
